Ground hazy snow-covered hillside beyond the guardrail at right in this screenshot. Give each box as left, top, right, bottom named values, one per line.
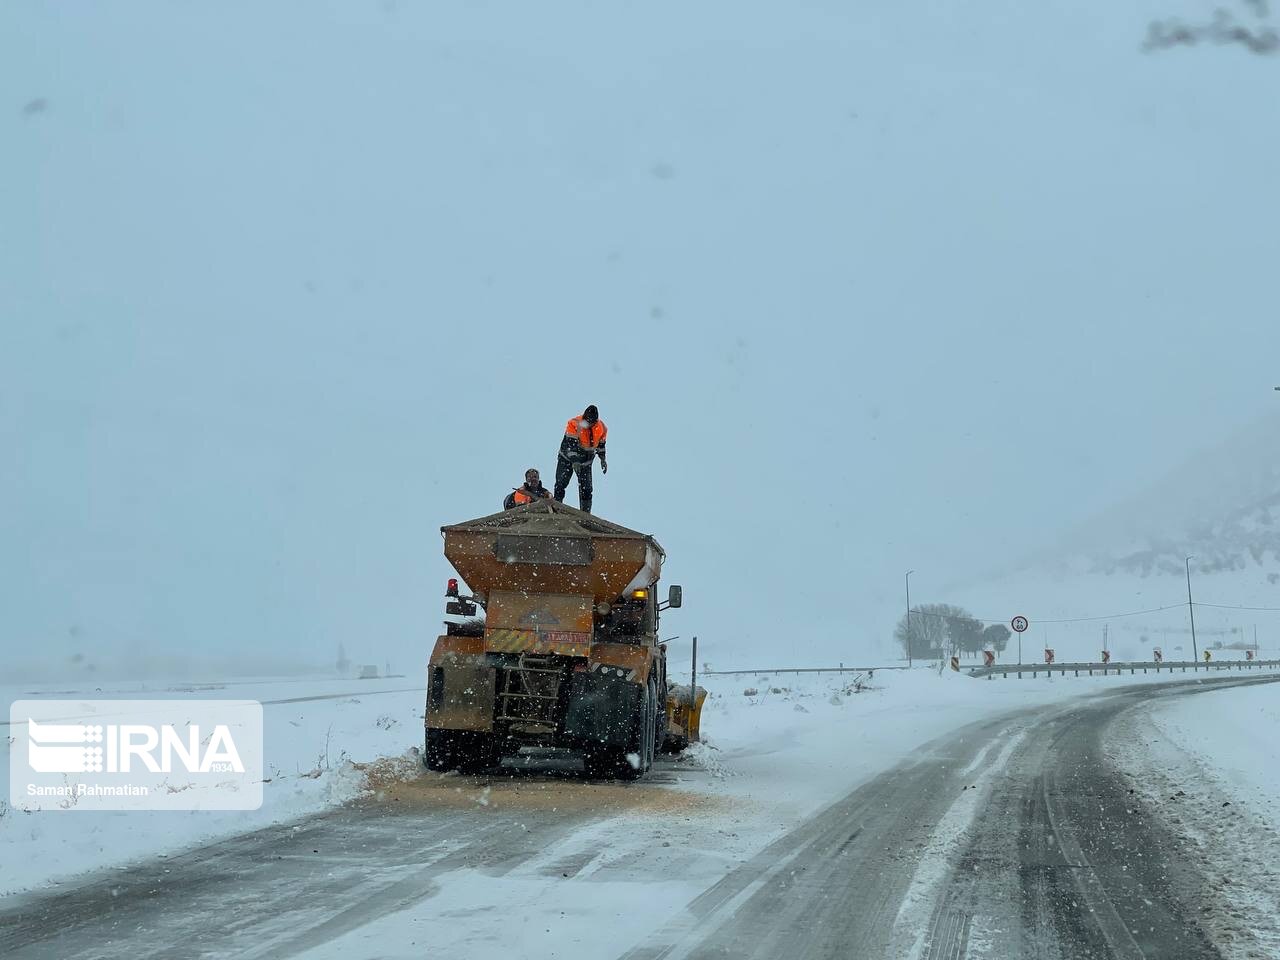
left=946, top=417, right=1280, bottom=659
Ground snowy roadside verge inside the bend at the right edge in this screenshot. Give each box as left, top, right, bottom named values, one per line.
left=1111, top=685, right=1280, bottom=960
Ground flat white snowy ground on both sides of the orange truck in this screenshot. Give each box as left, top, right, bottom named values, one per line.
left=0, top=668, right=1274, bottom=916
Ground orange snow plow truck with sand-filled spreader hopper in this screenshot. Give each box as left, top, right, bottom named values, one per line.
left=424, top=499, right=705, bottom=780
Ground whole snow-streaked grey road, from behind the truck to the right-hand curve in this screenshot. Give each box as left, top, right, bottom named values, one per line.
left=0, top=678, right=1266, bottom=960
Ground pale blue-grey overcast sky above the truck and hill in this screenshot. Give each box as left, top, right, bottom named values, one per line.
left=0, top=0, right=1280, bottom=672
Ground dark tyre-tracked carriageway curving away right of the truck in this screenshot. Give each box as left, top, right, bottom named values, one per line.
left=626, top=680, right=1272, bottom=960
